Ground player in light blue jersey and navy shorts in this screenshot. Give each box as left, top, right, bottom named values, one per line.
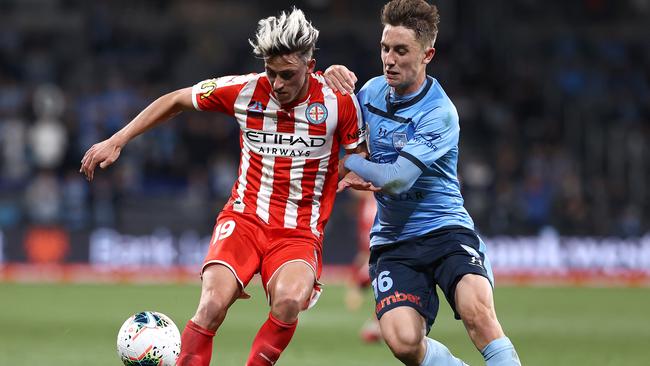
left=325, top=0, right=521, bottom=366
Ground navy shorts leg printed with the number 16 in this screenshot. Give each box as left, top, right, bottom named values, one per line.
left=369, top=245, right=439, bottom=330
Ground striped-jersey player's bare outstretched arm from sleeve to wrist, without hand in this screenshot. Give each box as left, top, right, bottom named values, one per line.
left=111, top=89, right=193, bottom=146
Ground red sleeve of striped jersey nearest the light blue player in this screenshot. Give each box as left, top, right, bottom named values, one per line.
left=337, top=93, right=366, bottom=150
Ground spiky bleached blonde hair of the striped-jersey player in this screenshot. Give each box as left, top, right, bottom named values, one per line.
left=248, top=7, right=318, bottom=61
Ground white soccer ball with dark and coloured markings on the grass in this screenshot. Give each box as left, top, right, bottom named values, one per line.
left=117, top=311, right=181, bottom=366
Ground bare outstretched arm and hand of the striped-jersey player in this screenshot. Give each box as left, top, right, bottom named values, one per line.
left=79, top=88, right=194, bottom=181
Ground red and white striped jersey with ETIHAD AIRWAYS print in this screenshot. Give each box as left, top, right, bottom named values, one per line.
left=192, top=73, right=365, bottom=238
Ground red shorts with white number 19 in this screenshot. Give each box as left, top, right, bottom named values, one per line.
left=201, top=211, right=323, bottom=306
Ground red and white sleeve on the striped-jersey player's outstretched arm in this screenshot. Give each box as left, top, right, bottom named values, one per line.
left=192, top=74, right=255, bottom=116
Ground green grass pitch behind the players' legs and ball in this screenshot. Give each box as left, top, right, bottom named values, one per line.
left=0, top=284, right=650, bottom=366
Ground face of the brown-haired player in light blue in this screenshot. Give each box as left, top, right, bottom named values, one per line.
left=381, top=25, right=435, bottom=94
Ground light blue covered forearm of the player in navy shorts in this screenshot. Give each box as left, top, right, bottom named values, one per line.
left=345, top=155, right=422, bottom=194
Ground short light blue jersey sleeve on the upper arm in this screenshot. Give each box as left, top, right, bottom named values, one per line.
left=400, top=104, right=460, bottom=171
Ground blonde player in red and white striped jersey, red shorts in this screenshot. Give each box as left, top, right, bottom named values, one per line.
left=81, top=9, right=365, bottom=366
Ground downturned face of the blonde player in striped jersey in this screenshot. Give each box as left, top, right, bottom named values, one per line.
left=265, top=53, right=316, bottom=104
